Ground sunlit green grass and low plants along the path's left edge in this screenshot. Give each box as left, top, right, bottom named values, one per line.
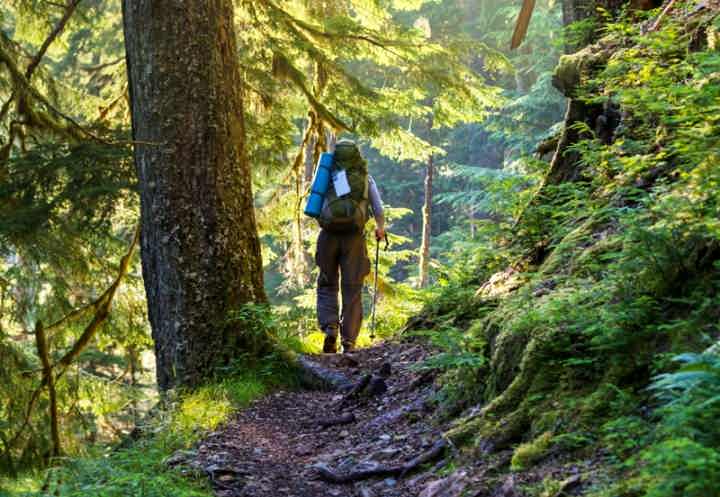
left=0, top=356, right=296, bottom=497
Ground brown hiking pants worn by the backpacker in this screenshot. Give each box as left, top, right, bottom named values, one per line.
left=315, top=230, right=370, bottom=348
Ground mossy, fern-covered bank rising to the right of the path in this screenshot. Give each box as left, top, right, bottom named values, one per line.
left=417, top=5, right=720, bottom=497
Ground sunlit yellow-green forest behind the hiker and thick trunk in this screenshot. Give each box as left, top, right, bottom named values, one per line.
left=0, top=0, right=566, bottom=475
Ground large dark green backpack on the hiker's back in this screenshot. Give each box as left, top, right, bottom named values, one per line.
left=318, top=140, right=368, bottom=233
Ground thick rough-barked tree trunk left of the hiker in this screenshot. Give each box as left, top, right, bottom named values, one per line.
left=123, top=0, right=266, bottom=389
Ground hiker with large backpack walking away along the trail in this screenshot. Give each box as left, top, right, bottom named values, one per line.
left=315, top=140, right=385, bottom=354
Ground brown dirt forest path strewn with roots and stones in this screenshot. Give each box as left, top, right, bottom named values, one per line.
left=183, top=343, right=456, bottom=497
